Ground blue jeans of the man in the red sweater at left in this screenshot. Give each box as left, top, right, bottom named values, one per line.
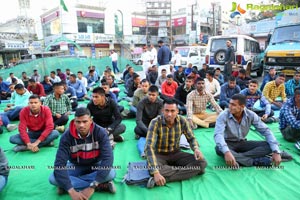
left=9, top=130, right=59, bottom=147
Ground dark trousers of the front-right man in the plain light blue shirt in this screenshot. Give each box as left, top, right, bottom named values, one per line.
left=216, top=140, right=272, bottom=167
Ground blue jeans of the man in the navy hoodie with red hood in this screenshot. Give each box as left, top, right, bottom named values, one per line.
left=49, top=161, right=116, bottom=190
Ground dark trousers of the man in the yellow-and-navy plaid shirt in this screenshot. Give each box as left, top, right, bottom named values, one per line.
left=155, top=151, right=207, bottom=182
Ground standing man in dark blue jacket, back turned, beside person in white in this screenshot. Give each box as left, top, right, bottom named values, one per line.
left=157, top=40, right=172, bottom=76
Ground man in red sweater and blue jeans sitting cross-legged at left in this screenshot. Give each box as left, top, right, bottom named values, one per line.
left=9, top=94, right=59, bottom=152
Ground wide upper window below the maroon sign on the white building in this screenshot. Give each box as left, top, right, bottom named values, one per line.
left=77, top=17, right=104, bottom=33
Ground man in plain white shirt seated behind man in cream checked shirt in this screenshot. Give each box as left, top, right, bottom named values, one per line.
left=204, top=70, right=221, bottom=99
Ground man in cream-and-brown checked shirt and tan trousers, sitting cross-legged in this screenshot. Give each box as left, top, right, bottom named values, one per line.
left=186, top=77, right=223, bottom=129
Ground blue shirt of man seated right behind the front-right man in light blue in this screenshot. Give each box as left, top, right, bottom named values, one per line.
left=240, top=88, right=271, bottom=115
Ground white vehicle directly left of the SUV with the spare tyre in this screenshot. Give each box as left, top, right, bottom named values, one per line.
left=172, top=46, right=206, bottom=69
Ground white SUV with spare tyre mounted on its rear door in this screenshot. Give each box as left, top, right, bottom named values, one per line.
left=205, top=35, right=264, bottom=76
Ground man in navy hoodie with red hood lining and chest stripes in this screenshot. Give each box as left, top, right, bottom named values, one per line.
left=49, top=108, right=116, bottom=199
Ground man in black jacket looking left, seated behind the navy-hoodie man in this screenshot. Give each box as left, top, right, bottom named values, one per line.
left=87, top=87, right=126, bottom=142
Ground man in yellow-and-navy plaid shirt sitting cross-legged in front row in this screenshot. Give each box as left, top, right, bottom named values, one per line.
left=145, top=99, right=207, bottom=188
